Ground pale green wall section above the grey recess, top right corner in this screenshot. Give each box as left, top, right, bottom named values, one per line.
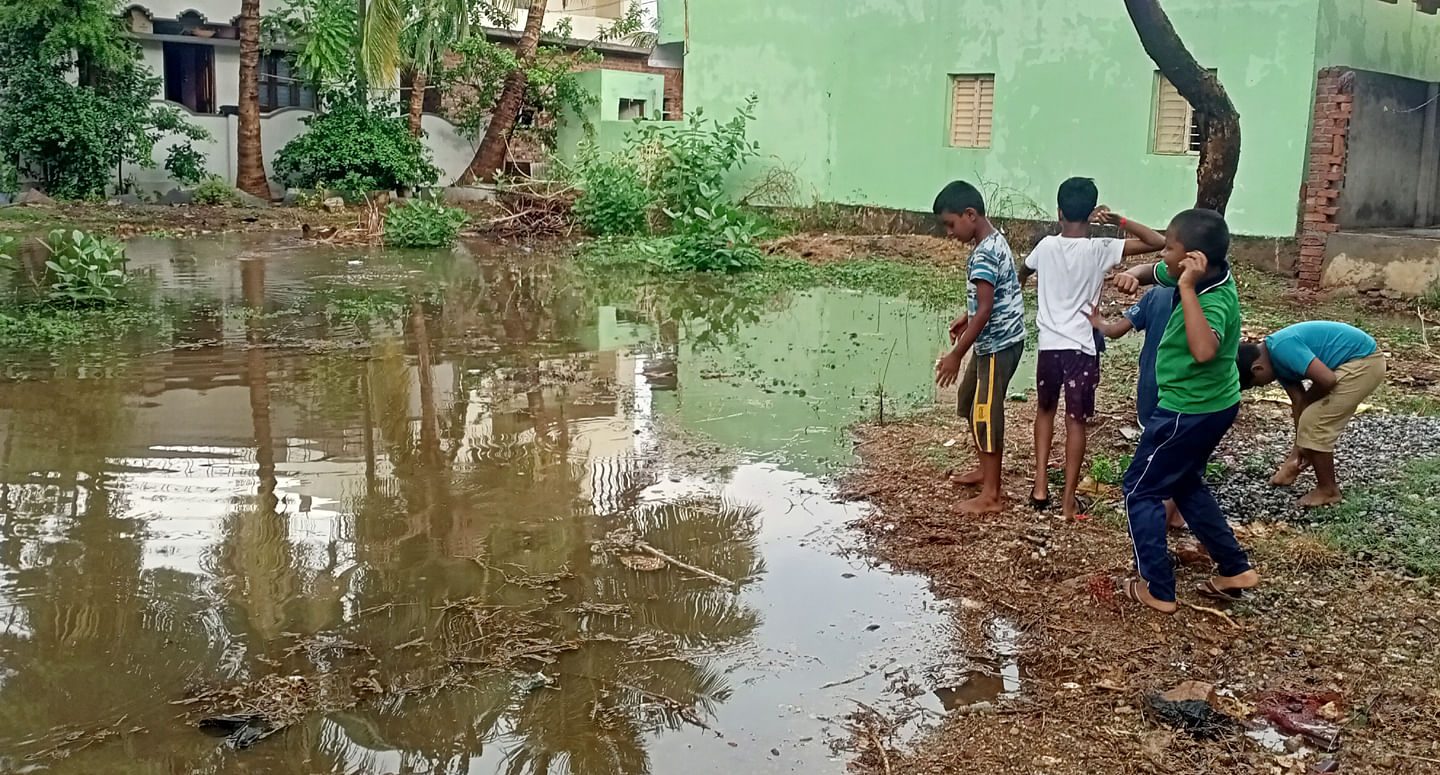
left=1316, top=0, right=1440, bottom=81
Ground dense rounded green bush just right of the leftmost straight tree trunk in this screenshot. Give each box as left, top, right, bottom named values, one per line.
left=275, top=95, right=441, bottom=193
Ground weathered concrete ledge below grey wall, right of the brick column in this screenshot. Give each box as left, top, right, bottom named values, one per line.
left=1320, top=232, right=1440, bottom=298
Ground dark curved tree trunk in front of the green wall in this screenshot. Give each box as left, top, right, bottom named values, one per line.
left=1125, top=0, right=1240, bottom=213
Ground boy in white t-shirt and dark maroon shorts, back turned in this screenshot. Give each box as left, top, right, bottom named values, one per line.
left=1021, top=177, right=1165, bottom=517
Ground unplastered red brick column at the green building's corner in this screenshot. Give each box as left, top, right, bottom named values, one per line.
left=1300, top=68, right=1355, bottom=288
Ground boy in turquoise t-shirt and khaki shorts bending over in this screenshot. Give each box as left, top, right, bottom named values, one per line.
left=1237, top=320, right=1385, bottom=509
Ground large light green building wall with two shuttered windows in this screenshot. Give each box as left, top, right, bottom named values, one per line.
left=685, top=0, right=1330, bottom=235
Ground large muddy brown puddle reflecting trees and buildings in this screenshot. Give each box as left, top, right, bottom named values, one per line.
left=0, top=239, right=1018, bottom=775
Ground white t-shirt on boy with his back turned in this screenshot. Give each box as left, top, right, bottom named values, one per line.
left=1025, top=236, right=1125, bottom=356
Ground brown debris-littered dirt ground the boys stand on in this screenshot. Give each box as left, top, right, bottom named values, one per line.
left=835, top=267, right=1440, bottom=775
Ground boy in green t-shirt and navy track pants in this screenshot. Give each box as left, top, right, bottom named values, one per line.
left=1115, top=210, right=1260, bottom=614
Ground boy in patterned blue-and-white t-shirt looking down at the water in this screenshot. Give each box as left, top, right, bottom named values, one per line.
left=935, top=180, right=1025, bottom=514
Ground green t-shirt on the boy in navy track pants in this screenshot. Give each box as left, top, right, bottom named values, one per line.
left=1155, top=264, right=1240, bottom=415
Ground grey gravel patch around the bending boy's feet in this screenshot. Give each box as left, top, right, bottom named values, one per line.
left=1211, top=412, right=1440, bottom=524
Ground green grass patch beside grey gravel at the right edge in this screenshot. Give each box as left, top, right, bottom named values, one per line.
left=1320, top=458, right=1440, bottom=578
